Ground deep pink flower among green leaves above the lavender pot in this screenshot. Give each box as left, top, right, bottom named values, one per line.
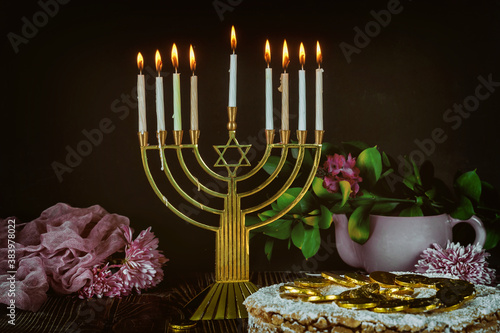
left=323, top=154, right=363, bottom=197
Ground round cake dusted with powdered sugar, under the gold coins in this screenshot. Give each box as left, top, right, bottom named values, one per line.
left=244, top=273, right=500, bottom=333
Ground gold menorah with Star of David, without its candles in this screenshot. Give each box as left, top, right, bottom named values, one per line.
left=138, top=107, right=324, bottom=320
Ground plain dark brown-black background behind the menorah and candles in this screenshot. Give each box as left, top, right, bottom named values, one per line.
left=0, top=0, right=500, bottom=271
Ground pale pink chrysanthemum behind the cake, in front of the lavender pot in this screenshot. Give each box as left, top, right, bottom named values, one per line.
left=415, top=241, right=495, bottom=285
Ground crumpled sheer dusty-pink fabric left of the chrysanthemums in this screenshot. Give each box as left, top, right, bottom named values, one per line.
left=0, top=203, right=129, bottom=311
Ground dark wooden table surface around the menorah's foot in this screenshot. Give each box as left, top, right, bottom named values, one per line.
left=0, top=272, right=304, bottom=333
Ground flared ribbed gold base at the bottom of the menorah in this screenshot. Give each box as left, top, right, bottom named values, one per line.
left=191, top=281, right=258, bottom=320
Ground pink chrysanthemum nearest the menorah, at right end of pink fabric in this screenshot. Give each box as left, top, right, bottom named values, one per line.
left=117, top=226, right=168, bottom=293
